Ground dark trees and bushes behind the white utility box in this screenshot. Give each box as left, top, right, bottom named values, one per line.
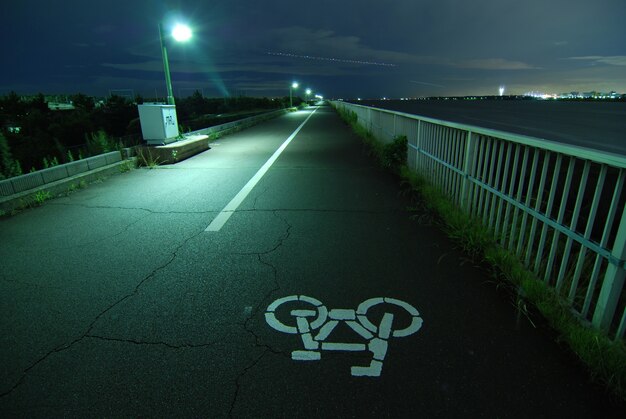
left=0, top=91, right=289, bottom=179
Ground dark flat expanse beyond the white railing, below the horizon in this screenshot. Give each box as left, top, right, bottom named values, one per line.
left=354, top=100, right=626, bottom=156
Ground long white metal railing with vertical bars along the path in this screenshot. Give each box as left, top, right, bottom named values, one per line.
left=332, top=102, right=626, bottom=339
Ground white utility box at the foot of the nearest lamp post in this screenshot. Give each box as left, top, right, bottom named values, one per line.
left=138, top=103, right=178, bottom=145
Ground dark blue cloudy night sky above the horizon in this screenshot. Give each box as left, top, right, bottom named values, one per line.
left=0, top=0, right=626, bottom=98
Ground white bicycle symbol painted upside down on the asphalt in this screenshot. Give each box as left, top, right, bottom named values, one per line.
left=265, top=295, right=423, bottom=377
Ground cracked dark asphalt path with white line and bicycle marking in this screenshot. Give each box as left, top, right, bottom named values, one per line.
left=0, top=106, right=624, bottom=417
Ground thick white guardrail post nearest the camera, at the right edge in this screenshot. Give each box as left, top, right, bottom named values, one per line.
left=592, top=207, right=626, bottom=330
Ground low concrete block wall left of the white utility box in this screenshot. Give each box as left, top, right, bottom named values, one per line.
left=0, top=151, right=122, bottom=196
